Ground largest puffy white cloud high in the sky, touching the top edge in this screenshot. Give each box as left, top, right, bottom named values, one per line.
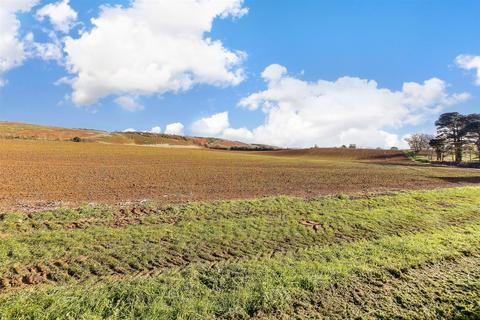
left=61, top=0, right=246, bottom=105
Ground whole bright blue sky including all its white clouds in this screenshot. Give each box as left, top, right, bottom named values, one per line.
left=0, top=0, right=480, bottom=148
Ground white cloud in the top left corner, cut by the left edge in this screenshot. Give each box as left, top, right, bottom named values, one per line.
left=0, top=0, right=38, bottom=87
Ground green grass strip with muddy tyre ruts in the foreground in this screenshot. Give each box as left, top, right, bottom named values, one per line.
left=0, top=187, right=480, bottom=319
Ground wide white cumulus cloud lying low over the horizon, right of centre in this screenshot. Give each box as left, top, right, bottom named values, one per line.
left=196, top=65, right=469, bottom=147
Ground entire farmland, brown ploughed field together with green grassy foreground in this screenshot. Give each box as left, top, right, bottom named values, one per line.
left=0, top=139, right=480, bottom=319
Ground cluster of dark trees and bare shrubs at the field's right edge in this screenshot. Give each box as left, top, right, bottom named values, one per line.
left=405, top=112, right=480, bottom=162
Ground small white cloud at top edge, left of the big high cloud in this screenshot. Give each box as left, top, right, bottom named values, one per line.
left=36, top=0, right=77, bottom=33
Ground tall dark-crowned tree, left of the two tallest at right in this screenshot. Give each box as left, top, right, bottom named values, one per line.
left=435, top=112, right=467, bottom=162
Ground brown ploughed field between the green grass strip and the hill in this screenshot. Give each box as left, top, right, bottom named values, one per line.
left=0, top=140, right=480, bottom=210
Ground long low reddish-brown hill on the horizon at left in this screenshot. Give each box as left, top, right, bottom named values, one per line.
left=0, top=121, right=277, bottom=151
